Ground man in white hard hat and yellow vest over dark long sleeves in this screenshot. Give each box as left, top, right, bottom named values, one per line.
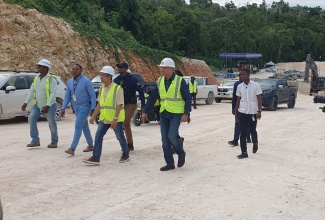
left=142, top=58, right=191, bottom=171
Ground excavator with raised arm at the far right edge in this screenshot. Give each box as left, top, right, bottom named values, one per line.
left=304, top=54, right=325, bottom=95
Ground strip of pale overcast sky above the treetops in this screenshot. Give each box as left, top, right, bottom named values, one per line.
left=212, top=0, right=325, bottom=9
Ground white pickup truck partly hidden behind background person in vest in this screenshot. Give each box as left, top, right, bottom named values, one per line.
left=183, top=76, right=218, bottom=105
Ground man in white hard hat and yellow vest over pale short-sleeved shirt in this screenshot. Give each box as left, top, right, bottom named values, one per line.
left=84, top=66, right=129, bottom=165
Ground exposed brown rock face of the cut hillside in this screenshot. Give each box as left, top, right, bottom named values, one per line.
left=0, top=1, right=217, bottom=84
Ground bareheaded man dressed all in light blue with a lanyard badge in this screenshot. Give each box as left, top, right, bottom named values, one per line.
left=61, top=64, right=96, bottom=155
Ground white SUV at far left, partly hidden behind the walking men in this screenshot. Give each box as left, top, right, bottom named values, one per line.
left=0, top=71, right=66, bottom=120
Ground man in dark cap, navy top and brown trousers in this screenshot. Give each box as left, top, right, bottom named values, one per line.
left=114, top=62, right=145, bottom=150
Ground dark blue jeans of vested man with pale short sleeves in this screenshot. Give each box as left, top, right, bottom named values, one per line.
left=93, top=121, right=129, bottom=160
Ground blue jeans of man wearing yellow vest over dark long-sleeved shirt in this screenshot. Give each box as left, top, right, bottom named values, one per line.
left=160, top=112, right=185, bottom=165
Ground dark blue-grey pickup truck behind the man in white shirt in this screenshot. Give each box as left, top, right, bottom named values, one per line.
left=256, top=79, right=297, bottom=111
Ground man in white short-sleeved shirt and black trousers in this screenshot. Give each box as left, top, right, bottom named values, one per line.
left=235, top=69, right=262, bottom=159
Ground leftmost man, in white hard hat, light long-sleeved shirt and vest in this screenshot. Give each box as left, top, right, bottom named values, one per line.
left=21, top=59, right=58, bottom=148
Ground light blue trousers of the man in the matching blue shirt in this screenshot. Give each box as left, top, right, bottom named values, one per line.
left=70, top=105, right=93, bottom=150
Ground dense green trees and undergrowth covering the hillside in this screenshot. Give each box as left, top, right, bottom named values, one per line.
left=6, top=0, right=325, bottom=69
